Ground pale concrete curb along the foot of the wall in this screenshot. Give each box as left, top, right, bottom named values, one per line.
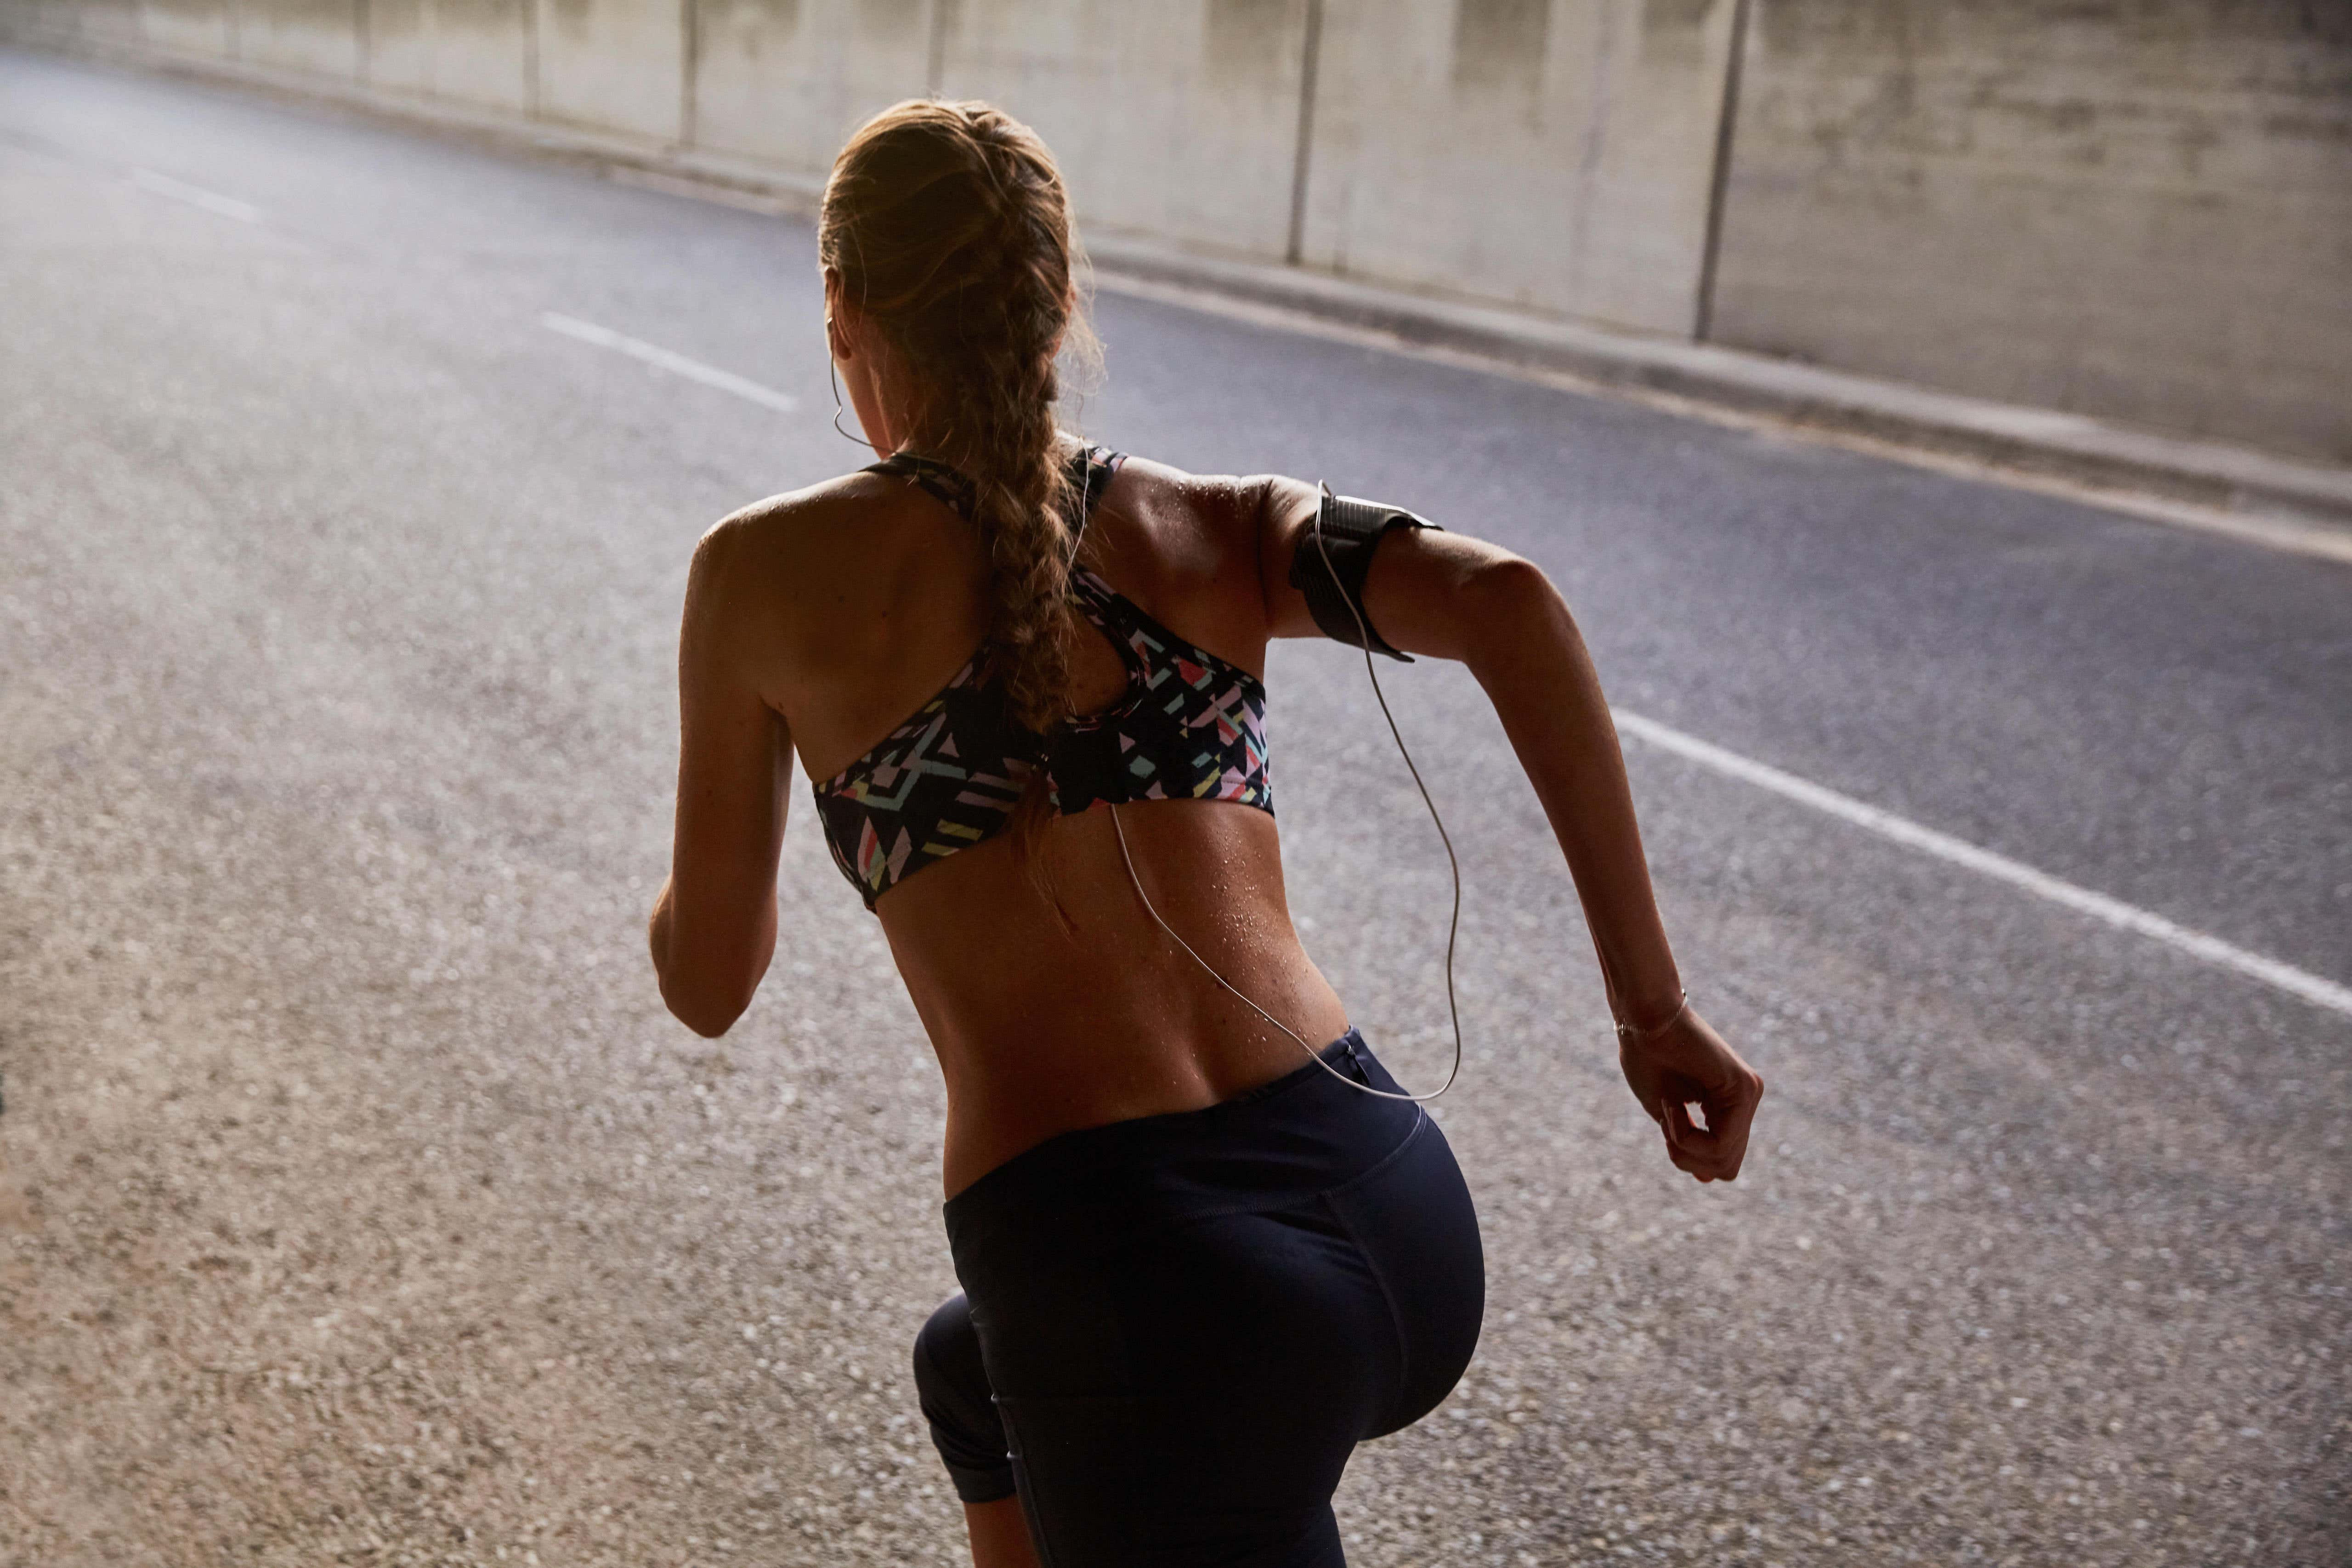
left=18, top=26, right=2352, bottom=540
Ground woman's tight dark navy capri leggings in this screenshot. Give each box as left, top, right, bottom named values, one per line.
left=915, top=1030, right=1486, bottom=1568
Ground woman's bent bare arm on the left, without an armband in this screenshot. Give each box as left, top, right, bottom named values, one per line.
left=649, top=520, right=793, bottom=1037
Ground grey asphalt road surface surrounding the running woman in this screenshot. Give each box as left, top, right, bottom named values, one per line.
left=0, top=54, right=2352, bottom=1568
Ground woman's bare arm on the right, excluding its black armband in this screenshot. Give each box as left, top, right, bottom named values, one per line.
left=1258, top=477, right=1764, bottom=1183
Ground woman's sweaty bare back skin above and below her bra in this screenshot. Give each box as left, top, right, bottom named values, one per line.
left=715, top=447, right=1348, bottom=1194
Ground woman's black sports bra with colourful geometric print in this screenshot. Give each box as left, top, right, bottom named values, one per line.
left=816, top=447, right=1275, bottom=910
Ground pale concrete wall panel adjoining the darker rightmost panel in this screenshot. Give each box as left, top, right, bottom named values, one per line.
left=1303, top=0, right=1734, bottom=334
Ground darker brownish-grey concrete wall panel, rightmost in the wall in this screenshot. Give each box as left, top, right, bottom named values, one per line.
left=1715, top=0, right=2352, bottom=461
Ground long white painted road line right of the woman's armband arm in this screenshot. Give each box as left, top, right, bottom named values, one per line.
left=1611, top=708, right=2352, bottom=1018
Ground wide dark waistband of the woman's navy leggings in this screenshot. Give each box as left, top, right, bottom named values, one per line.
left=941, top=1027, right=1421, bottom=1241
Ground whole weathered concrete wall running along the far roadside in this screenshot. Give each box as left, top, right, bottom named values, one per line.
left=0, top=0, right=2352, bottom=463
